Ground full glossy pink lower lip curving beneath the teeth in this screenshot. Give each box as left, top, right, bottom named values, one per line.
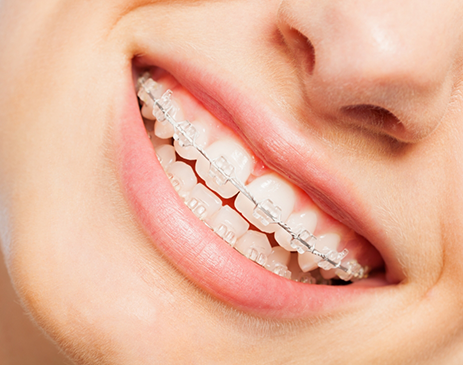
left=116, top=72, right=384, bottom=319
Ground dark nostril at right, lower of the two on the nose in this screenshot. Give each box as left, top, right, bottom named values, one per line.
left=342, top=104, right=403, bottom=132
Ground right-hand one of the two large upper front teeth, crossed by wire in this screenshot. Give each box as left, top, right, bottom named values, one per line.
left=235, top=173, right=296, bottom=233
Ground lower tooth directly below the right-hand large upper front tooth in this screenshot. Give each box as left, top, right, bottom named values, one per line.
left=235, top=231, right=272, bottom=266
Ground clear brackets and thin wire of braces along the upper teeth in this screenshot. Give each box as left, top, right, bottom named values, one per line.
left=137, top=73, right=368, bottom=281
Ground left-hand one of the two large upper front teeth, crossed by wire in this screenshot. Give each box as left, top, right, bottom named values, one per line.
left=196, top=140, right=253, bottom=198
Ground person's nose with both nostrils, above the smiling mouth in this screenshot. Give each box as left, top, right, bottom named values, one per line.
left=278, top=0, right=463, bottom=143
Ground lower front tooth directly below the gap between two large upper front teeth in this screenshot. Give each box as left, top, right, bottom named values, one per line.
left=209, top=205, right=249, bottom=247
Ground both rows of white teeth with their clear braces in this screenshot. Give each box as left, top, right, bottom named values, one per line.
left=138, top=75, right=366, bottom=282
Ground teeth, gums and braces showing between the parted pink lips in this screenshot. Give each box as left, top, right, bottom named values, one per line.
left=137, top=70, right=386, bottom=285
